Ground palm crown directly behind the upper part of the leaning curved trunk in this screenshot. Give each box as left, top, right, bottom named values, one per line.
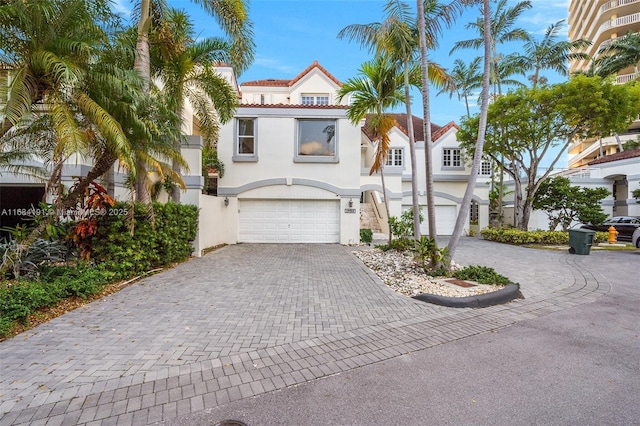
left=450, top=0, right=532, bottom=96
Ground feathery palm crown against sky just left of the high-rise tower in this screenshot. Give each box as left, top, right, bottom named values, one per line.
left=506, top=20, right=591, bottom=87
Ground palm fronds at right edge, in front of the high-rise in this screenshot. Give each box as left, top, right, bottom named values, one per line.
left=595, top=32, right=640, bottom=78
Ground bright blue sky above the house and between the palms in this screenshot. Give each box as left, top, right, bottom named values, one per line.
left=114, top=0, right=569, bottom=166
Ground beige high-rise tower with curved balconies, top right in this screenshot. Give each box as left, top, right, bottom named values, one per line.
left=568, top=0, right=640, bottom=168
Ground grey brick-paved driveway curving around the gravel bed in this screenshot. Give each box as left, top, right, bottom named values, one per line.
left=0, top=238, right=640, bottom=425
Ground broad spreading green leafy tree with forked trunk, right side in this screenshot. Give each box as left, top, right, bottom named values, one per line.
left=457, top=75, right=640, bottom=230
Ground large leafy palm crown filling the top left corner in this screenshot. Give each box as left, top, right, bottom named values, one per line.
left=0, top=0, right=137, bottom=200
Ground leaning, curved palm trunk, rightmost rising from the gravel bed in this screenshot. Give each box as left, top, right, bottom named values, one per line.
left=448, top=0, right=491, bottom=257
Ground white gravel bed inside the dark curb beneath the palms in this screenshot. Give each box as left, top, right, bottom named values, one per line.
left=353, top=249, right=504, bottom=297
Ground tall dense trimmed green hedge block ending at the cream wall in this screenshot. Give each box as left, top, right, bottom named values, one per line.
left=91, top=203, right=198, bottom=274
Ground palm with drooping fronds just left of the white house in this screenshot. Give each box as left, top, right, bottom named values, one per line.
left=152, top=9, right=238, bottom=202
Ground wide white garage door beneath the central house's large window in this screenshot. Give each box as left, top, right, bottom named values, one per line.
left=239, top=200, right=340, bottom=243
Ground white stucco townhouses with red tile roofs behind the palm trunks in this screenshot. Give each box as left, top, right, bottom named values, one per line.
left=195, top=62, right=490, bottom=248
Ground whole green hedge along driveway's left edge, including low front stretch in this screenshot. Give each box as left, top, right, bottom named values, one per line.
left=0, top=203, right=198, bottom=337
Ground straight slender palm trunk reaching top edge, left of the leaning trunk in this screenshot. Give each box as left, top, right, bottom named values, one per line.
left=416, top=0, right=437, bottom=246
